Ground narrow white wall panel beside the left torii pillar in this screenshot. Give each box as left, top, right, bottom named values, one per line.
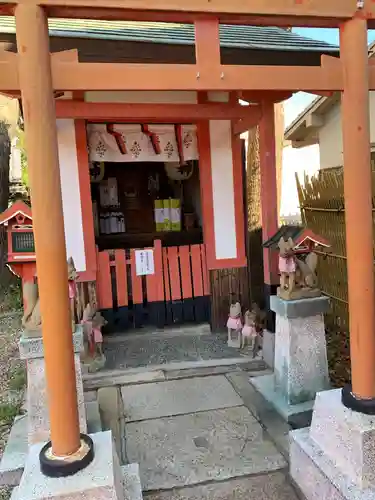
left=56, top=120, right=86, bottom=272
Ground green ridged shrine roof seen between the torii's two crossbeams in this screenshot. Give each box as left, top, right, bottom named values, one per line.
left=0, top=16, right=338, bottom=53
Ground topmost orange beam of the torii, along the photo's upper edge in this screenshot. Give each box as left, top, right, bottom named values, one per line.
left=0, top=0, right=375, bottom=27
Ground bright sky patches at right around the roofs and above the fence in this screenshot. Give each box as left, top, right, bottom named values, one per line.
left=280, top=28, right=375, bottom=215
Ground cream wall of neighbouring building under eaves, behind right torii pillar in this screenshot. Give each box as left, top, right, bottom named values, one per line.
left=319, top=92, right=375, bottom=168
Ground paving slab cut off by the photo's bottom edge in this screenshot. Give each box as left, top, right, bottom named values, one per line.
left=143, top=472, right=298, bottom=500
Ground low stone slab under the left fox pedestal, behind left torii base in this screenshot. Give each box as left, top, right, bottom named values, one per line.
left=0, top=401, right=102, bottom=486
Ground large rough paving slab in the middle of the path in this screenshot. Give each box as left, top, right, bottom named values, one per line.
left=125, top=406, right=286, bottom=491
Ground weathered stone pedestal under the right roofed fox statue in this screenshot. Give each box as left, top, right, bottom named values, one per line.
left=252, top=296, right=329, bottom=420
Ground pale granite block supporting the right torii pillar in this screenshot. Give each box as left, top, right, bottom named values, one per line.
left=290, top=389, right=375, bottom=500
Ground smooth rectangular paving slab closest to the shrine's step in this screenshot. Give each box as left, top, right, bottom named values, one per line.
left=121, top=375, right=243, bottom=422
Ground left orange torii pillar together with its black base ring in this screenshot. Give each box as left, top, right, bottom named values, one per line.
left=15, top=3, right=93, bottom=477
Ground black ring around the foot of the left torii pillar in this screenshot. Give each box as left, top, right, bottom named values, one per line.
left=39, top=434, right=94, bottom=478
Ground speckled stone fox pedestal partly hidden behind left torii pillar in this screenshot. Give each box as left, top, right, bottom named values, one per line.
left=19, top=326, right=87, bottom=444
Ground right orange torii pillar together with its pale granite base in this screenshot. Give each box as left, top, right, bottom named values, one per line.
left=290, top=16, right=375, bottom=500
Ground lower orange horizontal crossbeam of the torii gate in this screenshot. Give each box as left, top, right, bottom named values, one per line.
left=0, top=58, right=346, bottom=92
